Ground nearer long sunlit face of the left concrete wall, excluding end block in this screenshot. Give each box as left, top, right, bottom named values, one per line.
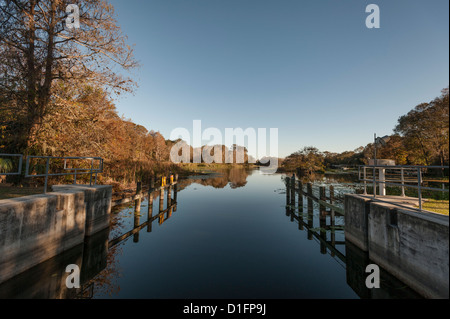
left=0, top=192, right=86, bottom=283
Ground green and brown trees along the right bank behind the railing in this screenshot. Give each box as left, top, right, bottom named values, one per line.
left=280, top=88, right=449, bottom=174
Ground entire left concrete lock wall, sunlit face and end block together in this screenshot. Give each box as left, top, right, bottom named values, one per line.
left=0, top=185, right=112, bottom=283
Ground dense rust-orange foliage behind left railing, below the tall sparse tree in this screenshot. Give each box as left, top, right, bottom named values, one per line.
left=31, top=83, right=180, bottom=183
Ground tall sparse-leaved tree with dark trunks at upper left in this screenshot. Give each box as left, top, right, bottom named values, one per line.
left=0, top=0, right=137, bottom=154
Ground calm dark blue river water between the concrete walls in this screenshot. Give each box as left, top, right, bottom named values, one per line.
left=0, top=168, right=419, bottom=299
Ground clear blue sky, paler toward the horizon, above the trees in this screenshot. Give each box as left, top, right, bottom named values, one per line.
left=110, top=0, right=449, bottom=156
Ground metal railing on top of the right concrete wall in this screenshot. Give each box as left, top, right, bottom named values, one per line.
left=358, top=165, right=449, bottom=212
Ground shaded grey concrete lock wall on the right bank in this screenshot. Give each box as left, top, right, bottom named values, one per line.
left=345, top=195, right=449, bottom=298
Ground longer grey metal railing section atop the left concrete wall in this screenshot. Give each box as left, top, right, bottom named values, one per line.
left=25, top=156, right=103, bottom=193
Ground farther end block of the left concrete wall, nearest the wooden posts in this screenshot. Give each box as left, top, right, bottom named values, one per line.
left=53, top=185, right=112, bottom=236
